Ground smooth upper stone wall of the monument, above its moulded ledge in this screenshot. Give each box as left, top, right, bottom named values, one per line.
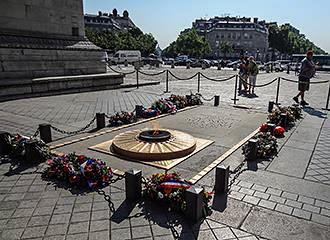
left=0, top=0, right=84, bottom=37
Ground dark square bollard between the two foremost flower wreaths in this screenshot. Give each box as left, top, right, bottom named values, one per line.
left=125, top=169, right=142, bottom=201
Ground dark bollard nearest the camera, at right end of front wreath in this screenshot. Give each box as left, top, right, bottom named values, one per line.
left=185, top=187, right=204, bottom=222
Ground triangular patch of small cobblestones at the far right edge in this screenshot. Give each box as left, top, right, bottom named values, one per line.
left=305, top=115, right=330, bottom=185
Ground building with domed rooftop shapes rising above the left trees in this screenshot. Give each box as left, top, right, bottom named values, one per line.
left=84, top=9, right=136, bottom=31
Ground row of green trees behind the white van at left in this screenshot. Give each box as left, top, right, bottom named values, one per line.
left=86, top=28, right=157, bottom=56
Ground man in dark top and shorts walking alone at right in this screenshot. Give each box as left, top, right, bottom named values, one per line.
left=293, top=50, right=315, bottom=106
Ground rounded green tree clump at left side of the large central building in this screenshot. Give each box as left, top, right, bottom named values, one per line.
left=164, top=29, right=211, bottom=58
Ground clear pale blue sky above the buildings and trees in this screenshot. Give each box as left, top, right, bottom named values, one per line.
left=83, top=0, right=330, bottom=53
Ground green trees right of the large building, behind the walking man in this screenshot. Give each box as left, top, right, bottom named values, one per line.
left=268, top=24, right=326, bottom=55
